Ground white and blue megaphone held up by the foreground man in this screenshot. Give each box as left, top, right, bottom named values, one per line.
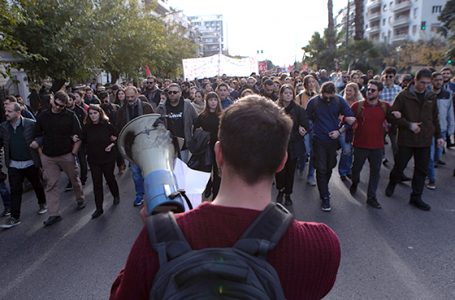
left=117, top=114, right=186, bottom=215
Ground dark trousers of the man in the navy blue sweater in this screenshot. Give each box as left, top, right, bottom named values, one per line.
left=312, top=139, right=338, bottom=198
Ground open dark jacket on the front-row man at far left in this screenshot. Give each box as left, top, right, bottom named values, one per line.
left=0, top=117, right=41, bottom=168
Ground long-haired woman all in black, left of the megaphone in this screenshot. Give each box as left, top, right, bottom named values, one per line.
left=82, top=105, right=120, bottom=219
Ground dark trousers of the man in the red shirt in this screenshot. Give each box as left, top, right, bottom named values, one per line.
left=351, top=147, right=384, bottom=199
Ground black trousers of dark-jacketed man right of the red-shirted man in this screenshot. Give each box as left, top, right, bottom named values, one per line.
left=390, top=146, right=430, bottom=200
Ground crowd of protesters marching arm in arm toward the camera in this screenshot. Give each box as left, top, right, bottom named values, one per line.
left=0, top=67, right=455, bottom=229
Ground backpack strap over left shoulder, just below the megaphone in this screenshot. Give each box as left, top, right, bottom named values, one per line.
left=145, top=212, right=192, bottom=266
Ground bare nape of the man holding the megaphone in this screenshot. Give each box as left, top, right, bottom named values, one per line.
left=213, top=168, right=272, bottom=210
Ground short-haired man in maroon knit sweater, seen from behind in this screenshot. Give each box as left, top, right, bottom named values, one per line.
left=110, top=95, right=340, bottom=300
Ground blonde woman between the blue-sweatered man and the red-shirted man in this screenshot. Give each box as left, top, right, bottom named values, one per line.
left=338, top=82, right=363, bottom=181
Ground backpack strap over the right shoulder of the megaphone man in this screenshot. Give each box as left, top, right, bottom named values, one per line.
left=234, top=203, right=294, bottom=259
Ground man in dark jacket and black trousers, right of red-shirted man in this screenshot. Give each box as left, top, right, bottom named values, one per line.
left=386, top=68, right=444, bottom=210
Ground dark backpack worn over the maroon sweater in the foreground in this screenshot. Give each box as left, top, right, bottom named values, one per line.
left=146, top=203, right=293, bottom=300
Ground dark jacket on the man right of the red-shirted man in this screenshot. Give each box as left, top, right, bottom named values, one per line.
left=392, top=85, right=441, bottom=147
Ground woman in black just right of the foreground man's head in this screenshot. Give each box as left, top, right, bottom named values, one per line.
left=275, top=84, right=309, bottom=205
